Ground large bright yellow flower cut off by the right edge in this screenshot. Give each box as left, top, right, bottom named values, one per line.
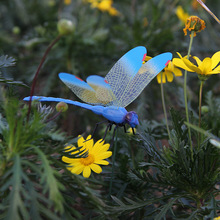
left=173, top=51, right=220, bottom=80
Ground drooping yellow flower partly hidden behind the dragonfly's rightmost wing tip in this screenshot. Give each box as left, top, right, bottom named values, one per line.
left=157, top=61, right=182, bottom=83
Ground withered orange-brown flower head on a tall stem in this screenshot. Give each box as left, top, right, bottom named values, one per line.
left=183, top=16, right=205, bottom=36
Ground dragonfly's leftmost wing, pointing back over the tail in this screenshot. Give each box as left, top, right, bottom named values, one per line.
left=59, top=73, right=100, bottom=104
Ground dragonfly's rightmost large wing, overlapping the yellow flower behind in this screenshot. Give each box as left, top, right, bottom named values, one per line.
left=114, top=53, right=172, bottom=107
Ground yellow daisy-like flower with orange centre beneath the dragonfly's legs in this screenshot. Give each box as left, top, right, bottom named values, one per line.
left=62, top=135, right=112, bottom=178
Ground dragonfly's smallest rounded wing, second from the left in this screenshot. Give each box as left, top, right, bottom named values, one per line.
left=86, top=75, right=113, bottom=105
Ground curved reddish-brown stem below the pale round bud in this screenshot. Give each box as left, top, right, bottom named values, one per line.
left=27, top=35, right=62, bottom=121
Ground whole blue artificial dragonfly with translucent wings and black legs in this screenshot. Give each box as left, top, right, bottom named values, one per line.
left=24, top=46, right=172, bottom=140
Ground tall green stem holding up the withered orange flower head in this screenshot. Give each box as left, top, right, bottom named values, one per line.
left=184, top=31, right=194, bottom=161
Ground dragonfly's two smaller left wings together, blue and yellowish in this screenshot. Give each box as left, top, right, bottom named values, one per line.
left=59, top=73, right=112, bottom=105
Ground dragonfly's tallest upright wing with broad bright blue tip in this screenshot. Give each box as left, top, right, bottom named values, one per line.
left=105, top=46, right=147, bottom=106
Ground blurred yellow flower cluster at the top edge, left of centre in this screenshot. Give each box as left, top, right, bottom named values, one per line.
left=85, top=0, right=120, bottom=16
